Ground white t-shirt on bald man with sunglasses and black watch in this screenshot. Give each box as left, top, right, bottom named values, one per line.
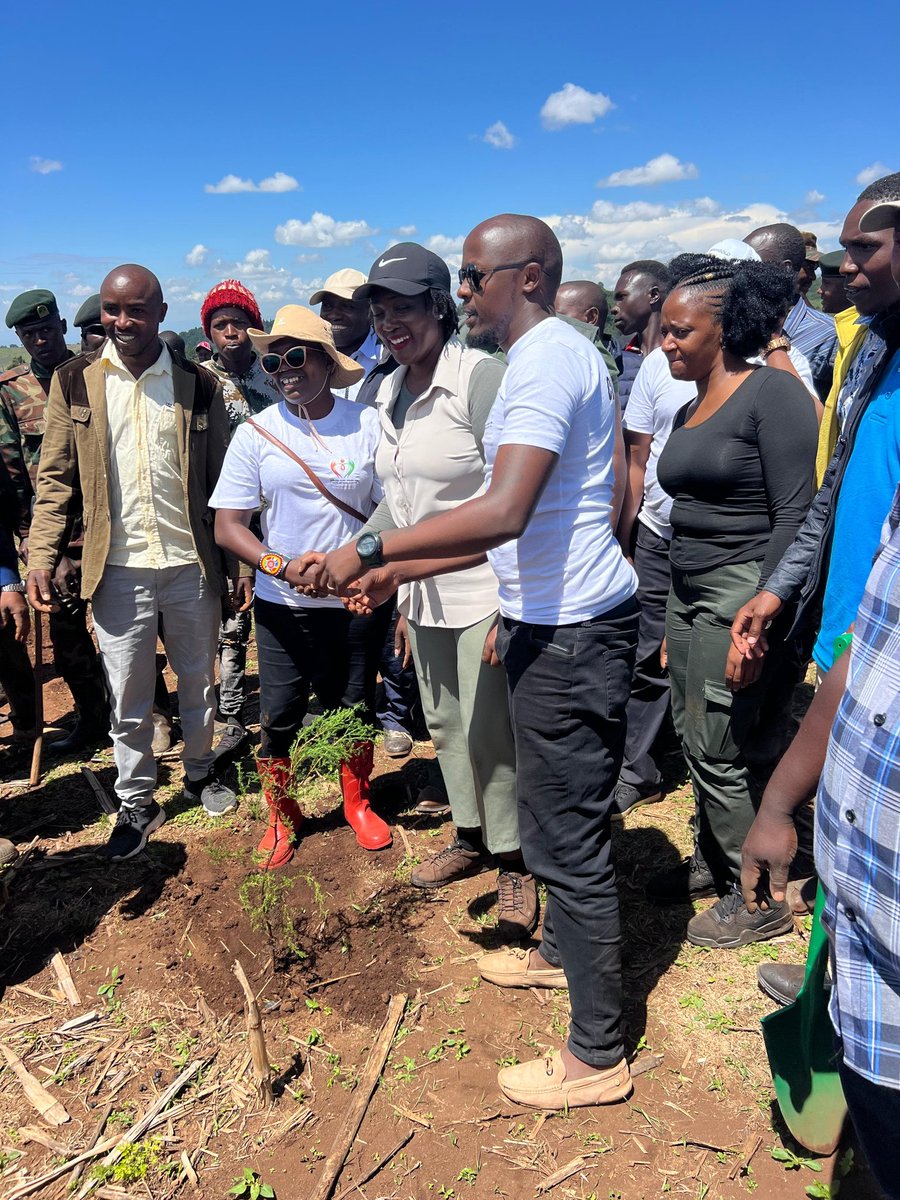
left=485, top=317, right=637, bottom=625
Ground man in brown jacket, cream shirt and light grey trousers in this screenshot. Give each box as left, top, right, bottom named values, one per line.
left=28, top=264, right=236, bottom=860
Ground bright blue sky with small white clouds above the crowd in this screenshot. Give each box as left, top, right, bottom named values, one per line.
left=0, top=0, right=900, bottom=340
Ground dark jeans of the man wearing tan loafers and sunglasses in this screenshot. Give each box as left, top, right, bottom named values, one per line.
left=497, top=600, right=640, bottom=1067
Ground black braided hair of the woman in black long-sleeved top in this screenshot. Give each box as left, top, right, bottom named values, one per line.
left=668, top=254, right=794, bottom=359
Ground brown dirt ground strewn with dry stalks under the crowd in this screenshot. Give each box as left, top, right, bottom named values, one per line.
left=0, top=628, right=876, bottom=1200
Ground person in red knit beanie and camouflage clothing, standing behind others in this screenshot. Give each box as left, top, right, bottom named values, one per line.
left=194, top=280, right=271, bottom=758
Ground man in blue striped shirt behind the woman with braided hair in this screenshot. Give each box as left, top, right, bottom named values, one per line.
left=744, top=221, right=838, bottom=403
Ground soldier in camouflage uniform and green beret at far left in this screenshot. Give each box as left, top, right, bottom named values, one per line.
left=0, top=289, right=109, bottom=754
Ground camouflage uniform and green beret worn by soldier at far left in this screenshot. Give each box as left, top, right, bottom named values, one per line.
left=0, top=292, right=108, bottom=727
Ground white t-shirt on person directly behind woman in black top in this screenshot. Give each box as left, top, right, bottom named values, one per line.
left=623, top=347, right=697, bottom=541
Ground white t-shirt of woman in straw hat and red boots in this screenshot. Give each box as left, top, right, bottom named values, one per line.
left=209, top=396, right=384, bottom=608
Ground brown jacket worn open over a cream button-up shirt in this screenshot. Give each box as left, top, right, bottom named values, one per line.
left=28, top=354, right=238, bottom=599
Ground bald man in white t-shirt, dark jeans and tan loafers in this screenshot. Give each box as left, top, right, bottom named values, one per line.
left=309, top=215, right=638, bottom=1110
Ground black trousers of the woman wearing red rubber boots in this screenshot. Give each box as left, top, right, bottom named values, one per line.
left=253, top=598, right=392, bottom=758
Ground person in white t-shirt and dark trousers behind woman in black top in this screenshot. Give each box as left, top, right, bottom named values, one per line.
left=616, top=347, right=697, bottom=814
